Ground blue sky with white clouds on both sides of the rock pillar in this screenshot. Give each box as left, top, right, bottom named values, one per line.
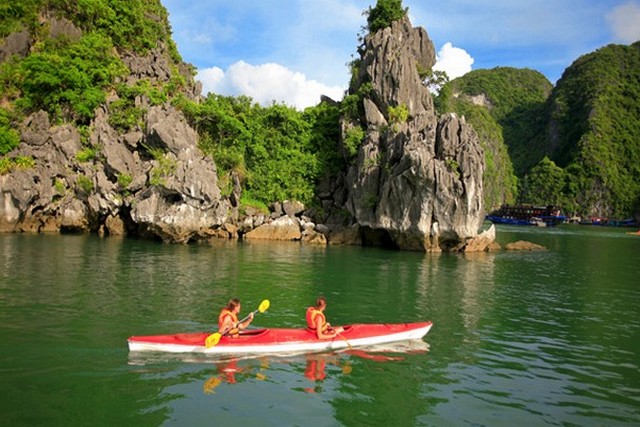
left=161, top=0, right=640, bottom=109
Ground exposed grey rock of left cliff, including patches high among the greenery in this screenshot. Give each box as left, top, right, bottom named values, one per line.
left=0, top=14, right=228, bottom=242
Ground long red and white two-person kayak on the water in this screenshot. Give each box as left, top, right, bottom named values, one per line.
left=127, top=322, right=432, bottom=354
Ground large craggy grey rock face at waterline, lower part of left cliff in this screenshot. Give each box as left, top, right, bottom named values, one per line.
left=0, top=106, right=228, bottom=242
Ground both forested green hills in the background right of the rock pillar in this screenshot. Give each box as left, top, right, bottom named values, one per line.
left=436, top=49, right=640, bottom=218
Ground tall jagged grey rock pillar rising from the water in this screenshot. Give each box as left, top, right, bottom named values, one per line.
left=344, top=17, right=484, bottom=252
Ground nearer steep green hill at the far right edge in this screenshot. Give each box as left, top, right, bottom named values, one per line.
left=547, top=42, right=640, bottom=217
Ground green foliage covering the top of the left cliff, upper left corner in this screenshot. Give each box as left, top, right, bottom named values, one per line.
left=0, top=0, right=181, bottom=127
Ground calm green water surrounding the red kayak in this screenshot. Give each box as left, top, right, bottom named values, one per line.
left=0, top=226, right=640, bottom=426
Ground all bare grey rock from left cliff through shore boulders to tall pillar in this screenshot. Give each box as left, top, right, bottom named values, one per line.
left=0, top=6, right=492, bottom=251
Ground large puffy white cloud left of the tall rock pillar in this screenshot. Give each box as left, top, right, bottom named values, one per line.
left=196, top=61, right=345, bottom=109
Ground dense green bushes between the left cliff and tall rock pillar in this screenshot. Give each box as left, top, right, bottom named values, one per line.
left=183, top=95, right=340, bottom=204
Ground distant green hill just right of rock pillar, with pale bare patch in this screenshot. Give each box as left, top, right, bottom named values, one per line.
left=435, top=67, right=551, bottom=209
